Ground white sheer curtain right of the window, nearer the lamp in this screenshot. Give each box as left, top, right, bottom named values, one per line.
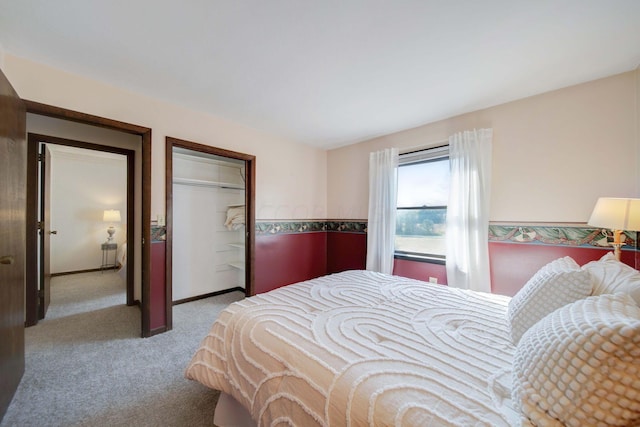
left=446, top=129, right=493, bottom=292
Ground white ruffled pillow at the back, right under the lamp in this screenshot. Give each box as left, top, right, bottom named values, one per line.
left=582, top=252, right=640, bottom=306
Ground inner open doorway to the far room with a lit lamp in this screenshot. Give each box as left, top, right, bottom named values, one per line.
left=25, top=133, right=139, bottom=326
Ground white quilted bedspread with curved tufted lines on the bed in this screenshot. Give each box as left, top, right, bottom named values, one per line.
left=186, top=271, right=514, bottom=426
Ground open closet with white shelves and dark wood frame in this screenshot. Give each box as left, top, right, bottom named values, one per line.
left=165, top=137, right=255, bottom=325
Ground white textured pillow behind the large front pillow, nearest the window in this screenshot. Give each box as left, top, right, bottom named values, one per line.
left=507, top=256, right=592, bottom=344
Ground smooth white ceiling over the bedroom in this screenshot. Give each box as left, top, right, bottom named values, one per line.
left=0, top=0, right=640, bottom=148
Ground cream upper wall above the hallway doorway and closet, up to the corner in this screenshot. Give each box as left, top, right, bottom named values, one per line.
left=3, top=54, right=327, bottom=219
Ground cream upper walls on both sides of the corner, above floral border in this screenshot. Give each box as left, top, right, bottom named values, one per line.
left=4, top=53, right=639, bottom=229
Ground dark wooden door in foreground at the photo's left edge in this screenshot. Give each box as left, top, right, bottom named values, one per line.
left=0, top=71, right=27, bottom=420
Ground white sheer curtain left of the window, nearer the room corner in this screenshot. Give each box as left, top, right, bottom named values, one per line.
left=367, top=148, right=398, bottom=274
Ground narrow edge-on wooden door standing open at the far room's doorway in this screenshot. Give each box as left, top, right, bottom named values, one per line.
left=38, top=144, right=52, bottom=319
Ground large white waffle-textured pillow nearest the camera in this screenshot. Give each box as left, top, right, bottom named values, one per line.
left=512, top=294, right=640, bottom=426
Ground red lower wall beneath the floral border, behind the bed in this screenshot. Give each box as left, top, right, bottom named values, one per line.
left=255, top=226, right=640, bottom=300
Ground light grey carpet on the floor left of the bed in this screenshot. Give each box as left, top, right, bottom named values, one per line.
left=0, top=272, right=244, bottom=427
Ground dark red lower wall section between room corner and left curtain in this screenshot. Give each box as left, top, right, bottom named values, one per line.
left=327, top=231, right=367, bottom=274
